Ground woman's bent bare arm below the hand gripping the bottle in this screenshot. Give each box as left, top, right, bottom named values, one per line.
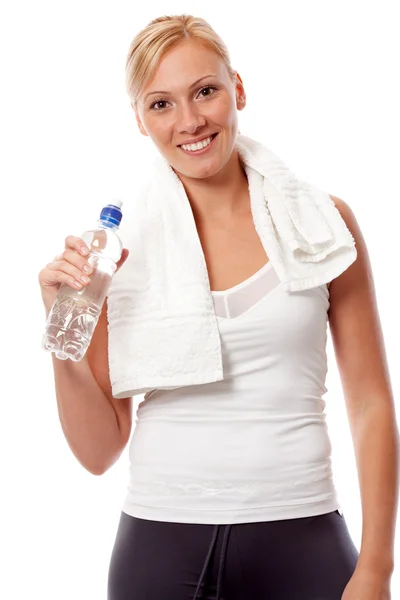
left=51, top=299, right=132, bottom=475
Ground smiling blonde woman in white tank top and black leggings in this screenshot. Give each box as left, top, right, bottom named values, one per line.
left=40, top=11, right=397, bottom=600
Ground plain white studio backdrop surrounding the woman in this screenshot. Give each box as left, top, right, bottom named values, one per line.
left=0, top=0, right=400, bottom=600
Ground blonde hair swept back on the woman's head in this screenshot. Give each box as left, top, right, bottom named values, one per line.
left=125, top=15, right=236, bottom=106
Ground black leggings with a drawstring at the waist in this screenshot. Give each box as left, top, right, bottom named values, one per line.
left=107, top=510, right=359, bottom=600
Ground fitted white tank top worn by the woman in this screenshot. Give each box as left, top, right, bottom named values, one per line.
left=123, top=263, right=340, bottom=524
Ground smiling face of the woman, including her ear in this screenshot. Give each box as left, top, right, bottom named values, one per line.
left=135, top=40, right=246, bottom=178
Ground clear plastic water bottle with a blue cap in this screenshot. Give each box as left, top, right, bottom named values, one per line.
left=42, top=200, right=123, bottom=362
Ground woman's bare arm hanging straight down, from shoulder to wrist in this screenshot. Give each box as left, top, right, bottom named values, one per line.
left=328, top=196, right=399, bottom=577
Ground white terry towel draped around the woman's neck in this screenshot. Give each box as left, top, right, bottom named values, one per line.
left=108, top=135, right=357, bottom=398
